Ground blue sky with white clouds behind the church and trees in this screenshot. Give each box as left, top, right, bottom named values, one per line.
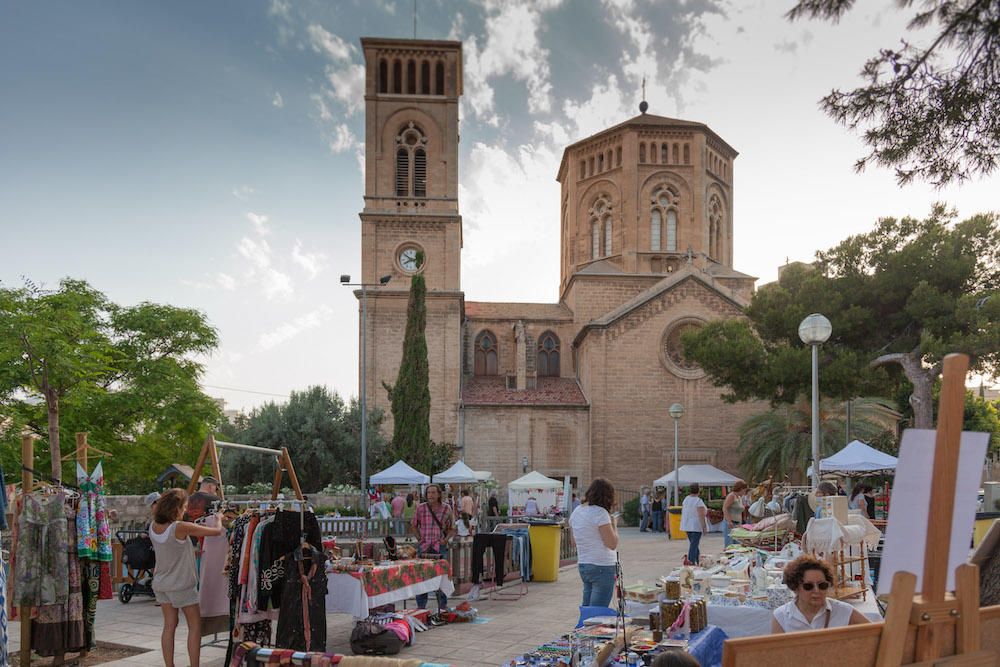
left=0, top=0, right=1000, bottom=410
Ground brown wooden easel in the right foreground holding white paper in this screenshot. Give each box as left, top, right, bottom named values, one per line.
left=722, top=354, right=1000, bottom=667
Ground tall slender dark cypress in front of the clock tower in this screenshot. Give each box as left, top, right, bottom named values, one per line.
left=382, top=253, right=454, bottom=474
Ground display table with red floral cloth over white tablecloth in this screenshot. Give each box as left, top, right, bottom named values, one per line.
left=326, top=559, right=455, bottom=619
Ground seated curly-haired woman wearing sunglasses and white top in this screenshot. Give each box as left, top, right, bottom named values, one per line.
left=771, top=556, right=869, bottom=634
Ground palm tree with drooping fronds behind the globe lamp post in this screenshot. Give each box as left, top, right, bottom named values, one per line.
left=738, top=398, right=896, bottom=480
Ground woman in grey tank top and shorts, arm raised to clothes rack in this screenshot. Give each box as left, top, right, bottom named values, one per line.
left=149, top=489, right=222, bottom=667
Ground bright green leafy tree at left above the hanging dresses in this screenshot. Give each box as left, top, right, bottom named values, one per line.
left=0, top=279, right=219, bottom=489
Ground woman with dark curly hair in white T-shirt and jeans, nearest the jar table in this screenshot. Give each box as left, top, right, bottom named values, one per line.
left=569, top=477, right=618, bottom=607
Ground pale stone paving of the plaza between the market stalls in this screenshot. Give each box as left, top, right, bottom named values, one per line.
left=10, top=528, right=722, bottom=667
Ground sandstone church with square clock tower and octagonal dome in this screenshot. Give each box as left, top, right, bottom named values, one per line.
left=358, top=38, right=760, bottom=489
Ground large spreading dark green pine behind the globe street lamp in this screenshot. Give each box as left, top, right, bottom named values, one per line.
left=683, top=205, right=1000, bottom=428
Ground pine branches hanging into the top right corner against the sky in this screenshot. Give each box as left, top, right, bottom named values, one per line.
left=787, top=0, right=1000, bottom=187
